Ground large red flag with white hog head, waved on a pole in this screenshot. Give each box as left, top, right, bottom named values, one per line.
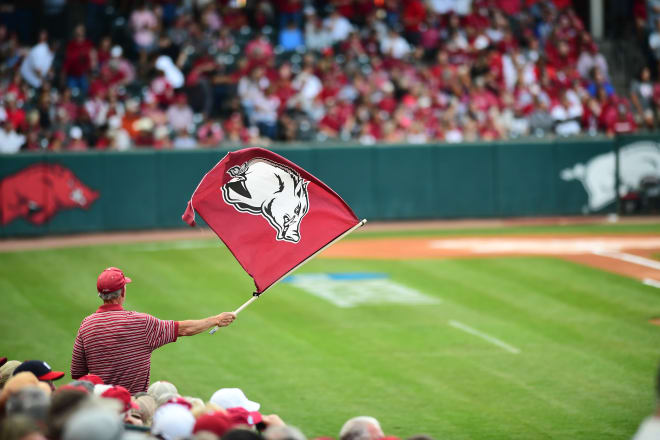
left=182, top=148, right=359, bottom=294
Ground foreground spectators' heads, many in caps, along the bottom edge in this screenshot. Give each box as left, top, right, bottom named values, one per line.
left=0, top=358, right=412, bottom=440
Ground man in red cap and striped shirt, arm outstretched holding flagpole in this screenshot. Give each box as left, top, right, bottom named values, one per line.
left=71, top=267, right=236, bottom=394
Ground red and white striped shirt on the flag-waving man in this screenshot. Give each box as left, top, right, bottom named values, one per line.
left=71, top=304, right=179, bottom=394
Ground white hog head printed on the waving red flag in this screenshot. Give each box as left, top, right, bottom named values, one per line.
left=222, top=158, right=309, bottom=243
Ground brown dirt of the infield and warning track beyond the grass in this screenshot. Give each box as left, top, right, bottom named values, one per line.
left=0, top=217, right=660, bottom=281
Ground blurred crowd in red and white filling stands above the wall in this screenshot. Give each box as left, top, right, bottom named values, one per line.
left=0, top=0, right=660, bottom=153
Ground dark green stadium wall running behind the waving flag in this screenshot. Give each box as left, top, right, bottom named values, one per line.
left=0, top=137, right=660, bottom=237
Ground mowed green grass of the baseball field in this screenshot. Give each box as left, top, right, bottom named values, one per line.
left=0, top=225, right=660, bottom=440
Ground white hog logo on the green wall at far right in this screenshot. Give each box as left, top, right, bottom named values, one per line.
left=560, top=141, right=660, bottom=211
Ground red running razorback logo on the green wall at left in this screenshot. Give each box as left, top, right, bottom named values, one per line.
left=0, top=163, right=99, bottom=225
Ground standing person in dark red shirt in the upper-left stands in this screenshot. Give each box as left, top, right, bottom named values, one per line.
left=62, top=24, right=96, bottom=94
